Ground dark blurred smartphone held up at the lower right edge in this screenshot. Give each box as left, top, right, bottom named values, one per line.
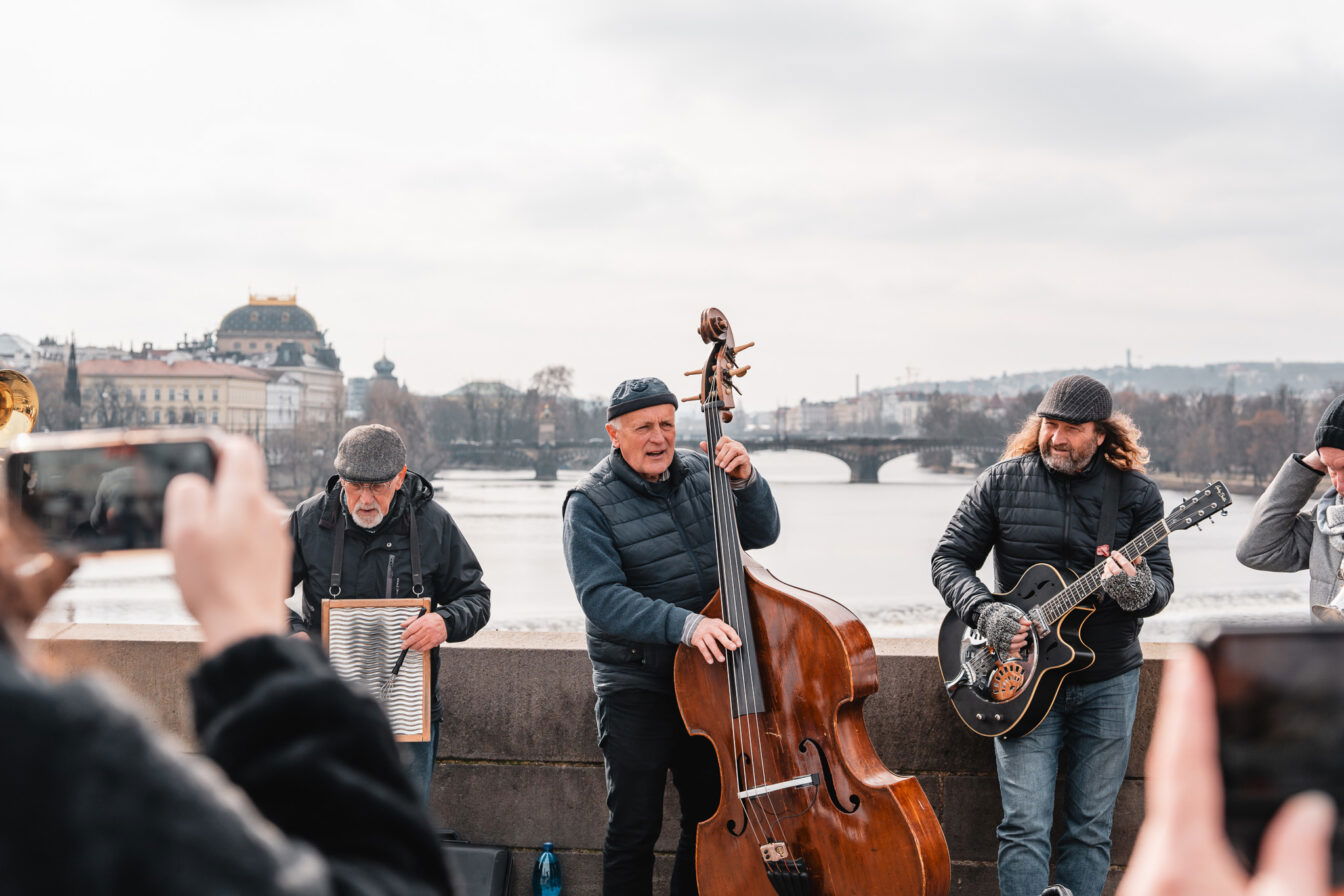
left=1202, top=626, right=1344, bottom=888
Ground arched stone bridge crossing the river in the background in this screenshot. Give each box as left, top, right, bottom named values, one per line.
left=438, top=435, right=1003, bottom=482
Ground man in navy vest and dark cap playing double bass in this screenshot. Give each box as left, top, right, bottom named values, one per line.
left=564, top=377, right=780, bottom=896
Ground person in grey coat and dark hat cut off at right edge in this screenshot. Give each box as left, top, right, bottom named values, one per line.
left=1236, top=395, right=1344, bottom=623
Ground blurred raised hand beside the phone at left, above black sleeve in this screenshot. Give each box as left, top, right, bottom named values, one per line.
left=164, top=437, right=293, bottom=657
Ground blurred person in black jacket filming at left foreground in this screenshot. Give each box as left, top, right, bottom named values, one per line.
left=0, top=438, right=452, bottom=896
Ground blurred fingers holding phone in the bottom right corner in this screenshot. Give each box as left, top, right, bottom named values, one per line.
left=1117, top=647, right=1335, bottom=896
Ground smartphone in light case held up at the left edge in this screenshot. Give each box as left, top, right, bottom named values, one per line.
left=0, top=427, right=219, bottom=555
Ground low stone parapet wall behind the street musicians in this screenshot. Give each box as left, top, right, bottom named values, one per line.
left=26, top=626, right=1164, bottom=896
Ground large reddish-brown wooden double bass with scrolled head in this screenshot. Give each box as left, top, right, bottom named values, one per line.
left=673, top=308, right=952, bottom=896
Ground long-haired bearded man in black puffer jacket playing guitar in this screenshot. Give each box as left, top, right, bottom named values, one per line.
left=933, top=375, right=1172, bottom=896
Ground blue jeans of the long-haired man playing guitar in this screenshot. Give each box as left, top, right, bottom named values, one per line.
left=995, top=669, right=1138, bottom=896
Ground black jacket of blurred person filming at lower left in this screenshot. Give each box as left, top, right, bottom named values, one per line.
left=0, top=637, right=449, bottom=896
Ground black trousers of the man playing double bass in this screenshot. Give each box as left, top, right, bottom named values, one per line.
left=597, top=690, right=719, bottom=896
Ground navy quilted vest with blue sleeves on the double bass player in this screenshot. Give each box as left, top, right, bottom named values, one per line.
left=564, top=451, right=780, bottom=695
